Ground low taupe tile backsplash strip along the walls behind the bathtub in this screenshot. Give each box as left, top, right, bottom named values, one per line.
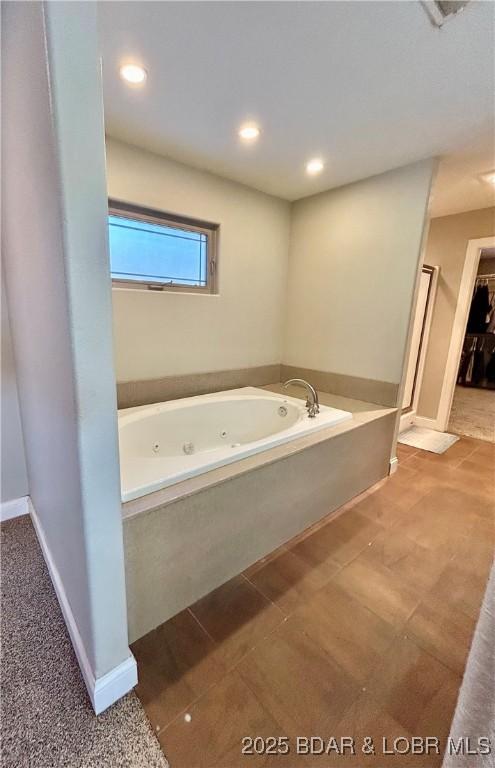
left=117, top=363, right=399, bottom=408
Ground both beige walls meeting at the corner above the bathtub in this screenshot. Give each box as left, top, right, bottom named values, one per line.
left=107, top=152, right=432, bottom=402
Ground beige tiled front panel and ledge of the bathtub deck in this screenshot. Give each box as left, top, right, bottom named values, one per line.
left=123, top=385, right=395, bottom=642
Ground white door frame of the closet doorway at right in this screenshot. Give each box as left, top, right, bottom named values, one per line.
left=435, top=235, right=495, bottom=432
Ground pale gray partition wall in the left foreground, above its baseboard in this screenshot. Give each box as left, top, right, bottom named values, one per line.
left=2, top=3, right=129, bottom=687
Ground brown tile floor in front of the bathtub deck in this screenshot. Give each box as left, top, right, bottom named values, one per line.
left=133, top=438, right=495, bottom=768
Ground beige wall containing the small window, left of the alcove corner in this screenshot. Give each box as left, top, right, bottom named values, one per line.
left=107, top=139, right=290, bottom=381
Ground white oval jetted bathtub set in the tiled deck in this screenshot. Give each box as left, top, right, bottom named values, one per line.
left=118, top=387, right=352, bottom=501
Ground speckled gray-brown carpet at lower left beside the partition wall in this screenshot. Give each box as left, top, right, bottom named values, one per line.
left=1, top=516, right=168, bottom=768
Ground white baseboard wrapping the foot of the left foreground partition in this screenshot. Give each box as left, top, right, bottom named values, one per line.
left=28, top=499, right=137, bottom=715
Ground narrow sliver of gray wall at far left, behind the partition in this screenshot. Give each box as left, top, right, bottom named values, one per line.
left=0, top=270, right=28, bottom=501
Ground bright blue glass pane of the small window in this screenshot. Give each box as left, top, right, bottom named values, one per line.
left=108, top=215, right=208, bottom=286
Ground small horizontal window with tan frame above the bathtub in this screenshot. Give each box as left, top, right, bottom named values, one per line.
left=108, top=200, right=218, bottom=293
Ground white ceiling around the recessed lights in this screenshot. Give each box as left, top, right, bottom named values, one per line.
left=98, top=0, right=495, bottom=210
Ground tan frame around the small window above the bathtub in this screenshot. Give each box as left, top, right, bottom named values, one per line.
left=108, top=199, right=219, bottom=294
